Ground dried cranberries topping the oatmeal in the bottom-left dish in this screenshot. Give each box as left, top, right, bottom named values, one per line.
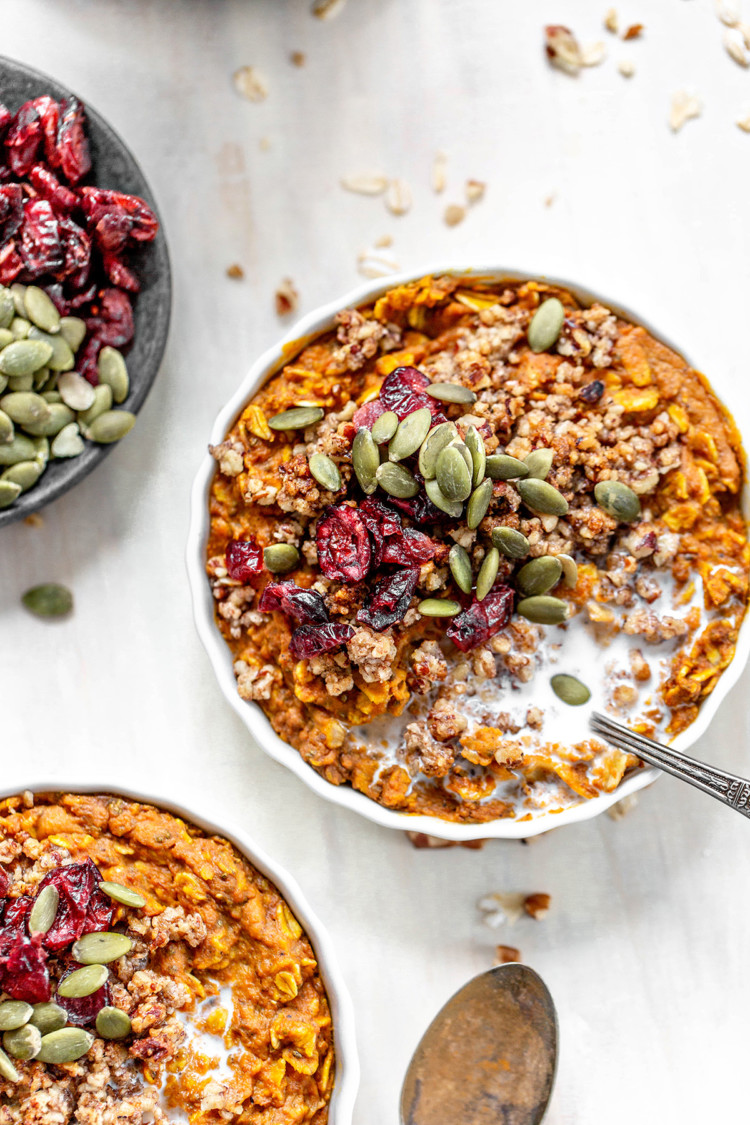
left=0, top=860, right=115, bottom=1027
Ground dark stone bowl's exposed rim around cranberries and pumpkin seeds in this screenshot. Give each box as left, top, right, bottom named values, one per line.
left=0, top=56, right=172, bottom=528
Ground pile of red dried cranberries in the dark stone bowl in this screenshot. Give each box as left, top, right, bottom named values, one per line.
left=0, top=97, right=159, bottom=385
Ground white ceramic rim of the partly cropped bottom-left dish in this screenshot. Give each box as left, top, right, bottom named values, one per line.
left=0, top=781, right=360, bottom=1125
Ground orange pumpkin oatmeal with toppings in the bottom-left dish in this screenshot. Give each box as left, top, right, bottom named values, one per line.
left=0, top=793, right=334, bottom=1125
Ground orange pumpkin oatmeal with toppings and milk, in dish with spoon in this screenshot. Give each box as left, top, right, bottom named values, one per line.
left=207, top=277, right=750, bottom=822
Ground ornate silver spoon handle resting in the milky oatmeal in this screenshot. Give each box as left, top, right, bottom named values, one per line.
left=589, top=711, right=750, bottom=817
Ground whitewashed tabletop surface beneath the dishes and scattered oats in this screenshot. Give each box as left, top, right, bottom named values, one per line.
left=0, top=0, right=750, bottom=1125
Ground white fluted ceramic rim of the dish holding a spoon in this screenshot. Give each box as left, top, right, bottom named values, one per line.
left=187, top=264, right=750, bottom=842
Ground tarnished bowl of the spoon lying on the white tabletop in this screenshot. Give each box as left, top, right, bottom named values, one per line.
left=400, top=963, right=558, bottom=1125
